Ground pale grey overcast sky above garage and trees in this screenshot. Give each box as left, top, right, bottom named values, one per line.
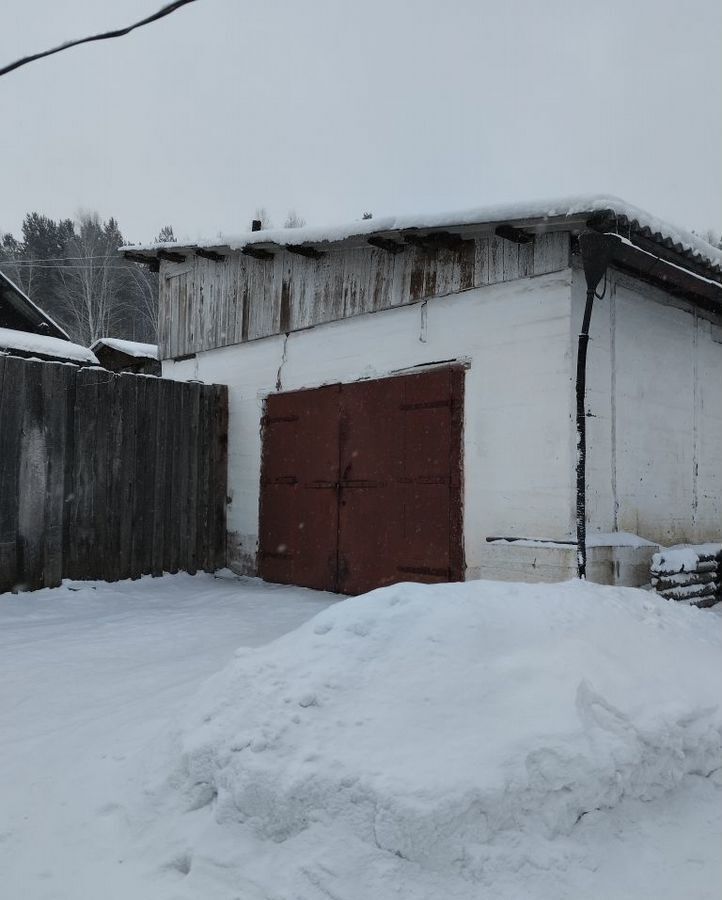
left=0, top=0, right=722, bottom=241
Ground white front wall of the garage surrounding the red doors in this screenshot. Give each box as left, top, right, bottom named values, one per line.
left=163, top=269, right=574, bottom=577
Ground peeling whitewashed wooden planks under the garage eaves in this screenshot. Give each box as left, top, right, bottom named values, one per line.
left=159, top=231, right=570, bottom=359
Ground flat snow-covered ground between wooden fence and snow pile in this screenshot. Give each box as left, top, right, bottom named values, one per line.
left=0, top=575, right=335, bottom=900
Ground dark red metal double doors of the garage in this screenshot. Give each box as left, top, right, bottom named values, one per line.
left=259, top=366, right=464, bottom=594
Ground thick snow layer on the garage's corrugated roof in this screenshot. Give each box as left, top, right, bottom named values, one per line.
left=122, top=194, right=722, bottom=275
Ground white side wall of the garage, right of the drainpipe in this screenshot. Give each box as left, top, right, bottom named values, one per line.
left=573, top=269, right=722, bottom=545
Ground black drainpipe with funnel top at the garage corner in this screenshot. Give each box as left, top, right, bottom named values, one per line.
left=576, top=231, right=617, bottom=579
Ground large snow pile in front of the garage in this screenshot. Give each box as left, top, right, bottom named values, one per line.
left=152, top=582, right=722, bottom=898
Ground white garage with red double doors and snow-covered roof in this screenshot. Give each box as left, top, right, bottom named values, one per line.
left=125, top=197, right=722, bottom=593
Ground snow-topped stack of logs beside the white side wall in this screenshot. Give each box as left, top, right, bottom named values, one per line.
left=651, top=544, right=722, bottom=606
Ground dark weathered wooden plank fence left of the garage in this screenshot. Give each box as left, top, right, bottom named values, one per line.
left=0, top=356, right=228, bottom=591
